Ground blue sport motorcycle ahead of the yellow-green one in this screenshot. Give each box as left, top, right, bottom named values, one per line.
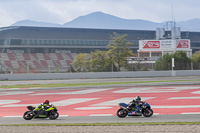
left=117, top=101, right=153, bottom=118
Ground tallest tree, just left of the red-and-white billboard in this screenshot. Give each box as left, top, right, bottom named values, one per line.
left=107, top=33, right=133, bottom=71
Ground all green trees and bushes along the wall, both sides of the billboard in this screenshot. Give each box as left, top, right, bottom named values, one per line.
left=70, top=33, right=200, bottom=72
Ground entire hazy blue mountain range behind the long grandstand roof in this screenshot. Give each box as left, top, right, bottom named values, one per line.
left=11, top=12, right=200, bottom=31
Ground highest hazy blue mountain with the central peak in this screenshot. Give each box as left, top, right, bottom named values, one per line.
left=63, top=12, right=161, bottom=30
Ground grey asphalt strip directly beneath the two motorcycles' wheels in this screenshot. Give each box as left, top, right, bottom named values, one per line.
left=0, top=114, right=200, bottom=125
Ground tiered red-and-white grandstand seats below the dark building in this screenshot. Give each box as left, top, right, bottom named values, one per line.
left=0, top=53, right=76, bottom=72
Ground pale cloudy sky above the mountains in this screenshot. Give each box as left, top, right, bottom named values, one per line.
left=0, top=0, right=200, bottom=27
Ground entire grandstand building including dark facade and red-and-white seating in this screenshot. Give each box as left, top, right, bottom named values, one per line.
left=0, top=26, right=200, bottom=73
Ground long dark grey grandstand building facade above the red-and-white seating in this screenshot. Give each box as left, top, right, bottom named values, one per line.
left=0, top=26, right=200, bottom=53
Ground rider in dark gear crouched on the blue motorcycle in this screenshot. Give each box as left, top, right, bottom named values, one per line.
left=128, top=96, right=143, bottom=115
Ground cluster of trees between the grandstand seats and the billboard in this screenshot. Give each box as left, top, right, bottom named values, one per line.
left=71, top=33, right=133, bottom=72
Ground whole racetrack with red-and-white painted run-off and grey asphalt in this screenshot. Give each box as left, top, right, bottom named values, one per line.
left=0, top=76, right=200, bottom=124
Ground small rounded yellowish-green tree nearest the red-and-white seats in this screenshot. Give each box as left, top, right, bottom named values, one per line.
left=72, top=53, right=90, bottom=72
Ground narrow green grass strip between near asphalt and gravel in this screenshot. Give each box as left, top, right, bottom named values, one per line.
left=0, top=122, right=200, bottom=126
